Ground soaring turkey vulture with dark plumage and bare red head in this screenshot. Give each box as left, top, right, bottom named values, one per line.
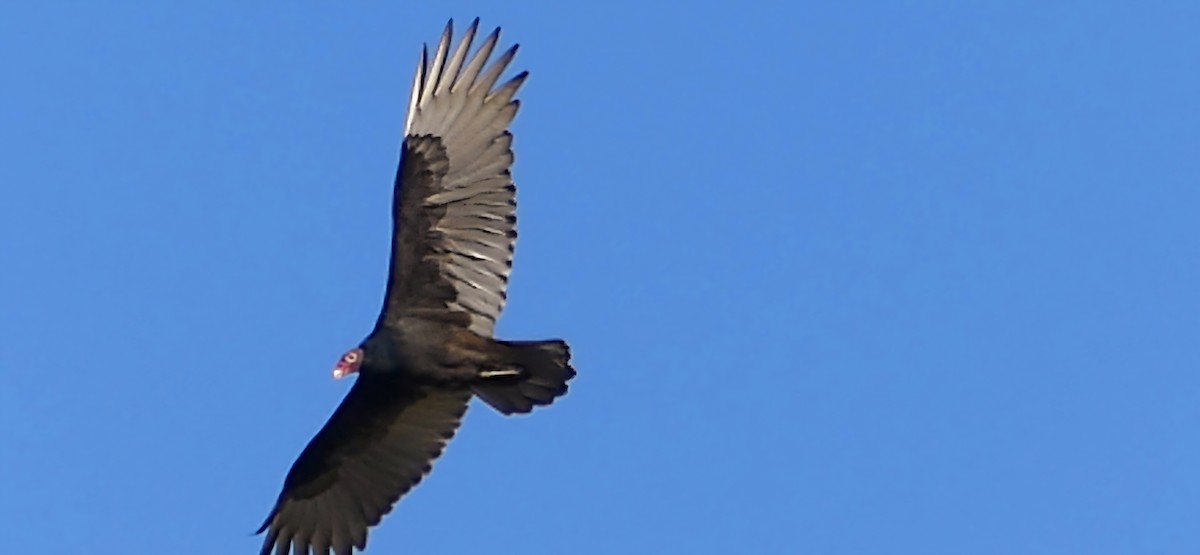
left=258, top=18, right=575, bottom=555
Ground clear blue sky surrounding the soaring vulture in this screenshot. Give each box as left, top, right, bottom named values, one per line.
left=0, top=1, right=1200, bottom=555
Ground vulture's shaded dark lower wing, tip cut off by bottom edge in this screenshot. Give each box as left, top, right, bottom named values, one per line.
left=258, top=374, right=470, bottom=555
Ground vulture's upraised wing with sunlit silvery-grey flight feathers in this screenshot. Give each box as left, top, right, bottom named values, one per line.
left=377, top=19, right=528, bottom=336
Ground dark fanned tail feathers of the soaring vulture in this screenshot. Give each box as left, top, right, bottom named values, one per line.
left=472, top=340, right=575, bottom=414
